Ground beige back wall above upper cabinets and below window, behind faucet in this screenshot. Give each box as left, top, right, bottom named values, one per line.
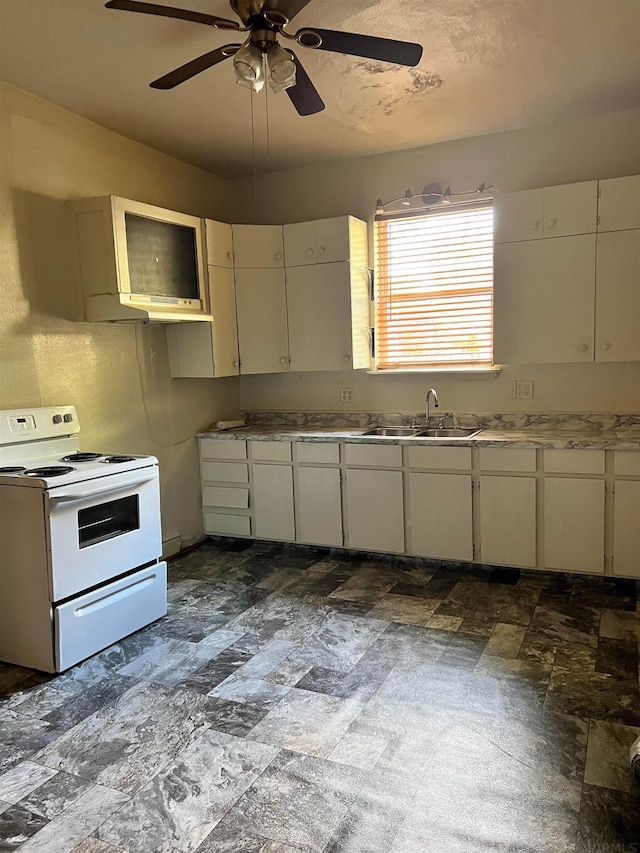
left=234, top=105, right=640, bottom=412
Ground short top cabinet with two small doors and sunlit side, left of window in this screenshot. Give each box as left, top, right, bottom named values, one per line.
left=283, top=216, right=368, bottom=267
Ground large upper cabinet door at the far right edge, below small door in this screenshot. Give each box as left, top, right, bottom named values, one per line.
left=595, top=230, right=640, bottom=361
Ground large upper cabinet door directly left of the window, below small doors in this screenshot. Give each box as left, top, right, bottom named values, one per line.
left=287, top=263, right=353, bottom=371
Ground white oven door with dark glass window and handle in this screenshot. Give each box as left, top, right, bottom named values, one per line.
left=46, top=465, right=162, bottom=602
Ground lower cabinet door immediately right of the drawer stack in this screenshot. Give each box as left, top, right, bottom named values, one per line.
left=253, top=463, right=296, bottom=542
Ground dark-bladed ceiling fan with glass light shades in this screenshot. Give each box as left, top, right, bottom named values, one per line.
left=106, top=0, right=422, bottom=116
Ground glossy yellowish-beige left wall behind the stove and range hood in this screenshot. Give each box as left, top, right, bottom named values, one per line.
left=0, top=86, right=239, bottom=545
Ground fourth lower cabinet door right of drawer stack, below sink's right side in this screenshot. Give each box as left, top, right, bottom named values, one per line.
left=409, top=473, right=473, bottom=561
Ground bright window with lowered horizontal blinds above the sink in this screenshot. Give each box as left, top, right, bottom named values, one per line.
left=375, top=201, right=493, bottom=370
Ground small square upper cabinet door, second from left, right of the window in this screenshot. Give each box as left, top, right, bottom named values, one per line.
left=542, top=181, right=598, bottom=237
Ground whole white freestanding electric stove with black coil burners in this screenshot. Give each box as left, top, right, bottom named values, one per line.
left=0, top=406, right=167, bottom=672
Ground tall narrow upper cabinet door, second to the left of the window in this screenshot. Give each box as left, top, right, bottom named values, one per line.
left=236, top=269, right=289, bottom=373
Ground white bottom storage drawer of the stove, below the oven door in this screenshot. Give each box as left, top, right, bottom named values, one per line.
left=53, top=563, right=167, bottom=672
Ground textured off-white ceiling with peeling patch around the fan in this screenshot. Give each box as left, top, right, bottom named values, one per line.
left=0, top=0, right=640, bottom=178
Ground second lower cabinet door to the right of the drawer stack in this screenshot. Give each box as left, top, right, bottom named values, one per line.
left=297, top=466, right=342, bottom=547
